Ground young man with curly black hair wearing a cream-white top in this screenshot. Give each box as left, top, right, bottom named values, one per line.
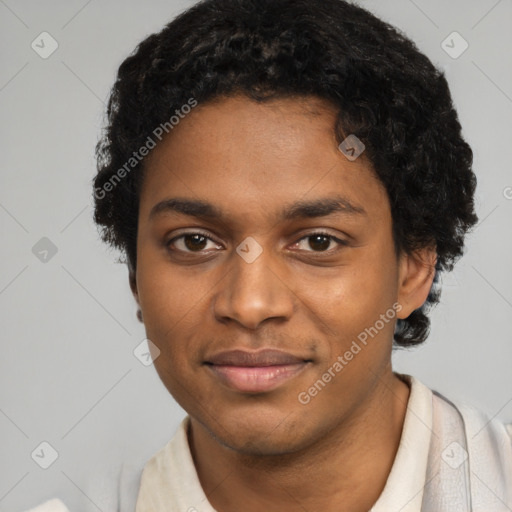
left=29, top=0, right=512, bottom=512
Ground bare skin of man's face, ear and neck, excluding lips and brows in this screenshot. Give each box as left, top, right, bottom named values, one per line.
left=130, top=96, right=435, bottom=512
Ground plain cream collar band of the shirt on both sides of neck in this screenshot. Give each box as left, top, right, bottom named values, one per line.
left=136, top=376, right=432, bottom=512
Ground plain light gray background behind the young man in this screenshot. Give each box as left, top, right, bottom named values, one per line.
left=0, top=0, right=512, bottom=512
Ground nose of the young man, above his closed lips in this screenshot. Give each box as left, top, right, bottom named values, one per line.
left=213, top=245, right=294, bottom=330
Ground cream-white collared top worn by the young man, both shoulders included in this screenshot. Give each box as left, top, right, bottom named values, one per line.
left=22, top=375, right=512, bottom=512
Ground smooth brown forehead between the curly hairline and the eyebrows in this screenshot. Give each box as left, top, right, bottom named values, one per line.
left=141, top=96, right=387, bottom=226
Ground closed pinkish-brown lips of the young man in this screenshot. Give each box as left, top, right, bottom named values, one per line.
left=204, top=349, right=311, bottom=393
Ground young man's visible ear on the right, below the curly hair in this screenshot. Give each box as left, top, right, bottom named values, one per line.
left=397, top=247, right=437, bottom=319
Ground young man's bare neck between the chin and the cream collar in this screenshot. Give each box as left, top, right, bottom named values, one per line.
left=189, top=369, right=409, bottom=512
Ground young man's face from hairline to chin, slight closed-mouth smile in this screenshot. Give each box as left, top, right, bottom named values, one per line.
left=133, top=97, right=429, bottom=454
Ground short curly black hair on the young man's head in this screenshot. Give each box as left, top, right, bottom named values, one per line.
left=94, top=0, right=478, bottom=347
